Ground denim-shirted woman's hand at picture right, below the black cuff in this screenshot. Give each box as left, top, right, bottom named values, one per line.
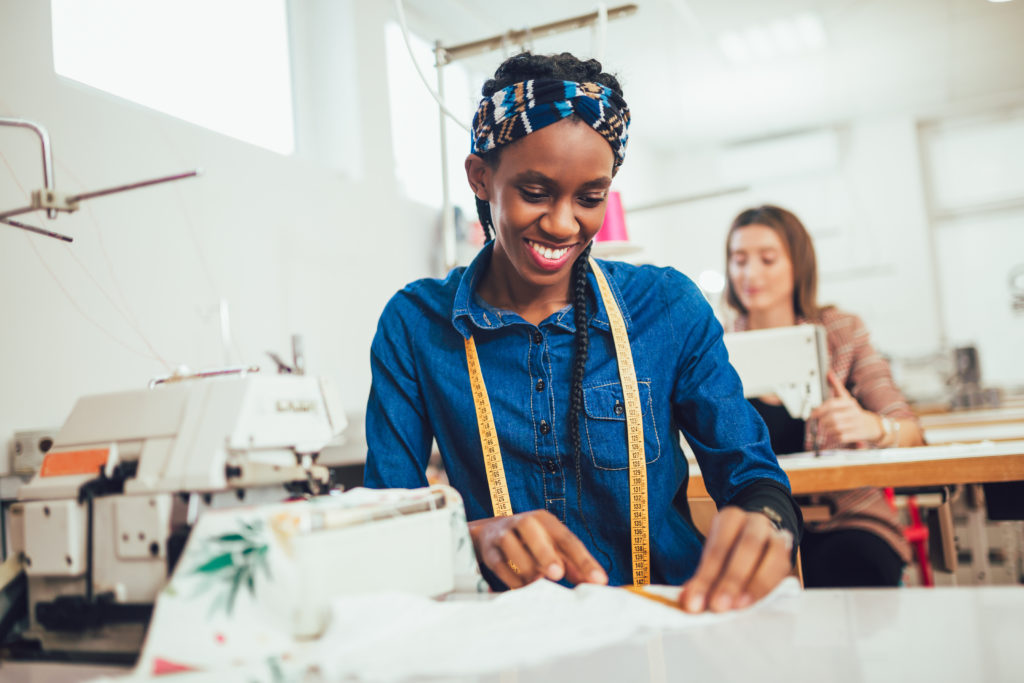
left=679, top=506, right=793, bottom=612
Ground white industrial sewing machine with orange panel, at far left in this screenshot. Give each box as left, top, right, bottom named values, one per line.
left=3, top=371, right=345, bottom=659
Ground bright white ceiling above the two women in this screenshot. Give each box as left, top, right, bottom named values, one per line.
left=393, top=0, right=1024, bottom=152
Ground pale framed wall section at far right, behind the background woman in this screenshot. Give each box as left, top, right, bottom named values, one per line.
left=922, top=110, right=1024, bottom=387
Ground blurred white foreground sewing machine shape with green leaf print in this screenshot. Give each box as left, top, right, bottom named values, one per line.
left=135, top=486, right=487, bottom=680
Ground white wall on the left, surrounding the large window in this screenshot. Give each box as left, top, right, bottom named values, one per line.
left=0, top=2, right=437, bottom=471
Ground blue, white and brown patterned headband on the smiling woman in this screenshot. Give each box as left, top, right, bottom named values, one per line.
left=469, top=79, right=630, bottom=171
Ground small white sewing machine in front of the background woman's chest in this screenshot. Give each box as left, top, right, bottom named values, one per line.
left=723, top=325, right=829, bottom=420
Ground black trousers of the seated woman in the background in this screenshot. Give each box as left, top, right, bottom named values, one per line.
left=800, top=529, right=903, bottom=588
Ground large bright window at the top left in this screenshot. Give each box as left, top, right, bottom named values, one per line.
left=51, top=0, right=295, bottom=154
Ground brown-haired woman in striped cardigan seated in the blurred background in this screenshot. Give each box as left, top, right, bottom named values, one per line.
left=726, top=206, right=925, bottom=588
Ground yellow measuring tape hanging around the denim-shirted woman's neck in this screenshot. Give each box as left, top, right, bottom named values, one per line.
left=466, top=259, right=650, bottom=586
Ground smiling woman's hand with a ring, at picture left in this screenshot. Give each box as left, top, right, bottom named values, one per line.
left=469, top=510, right=608, bottom=588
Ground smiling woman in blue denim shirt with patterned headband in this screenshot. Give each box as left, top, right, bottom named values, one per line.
left=366, top=53, right=801, bottom=611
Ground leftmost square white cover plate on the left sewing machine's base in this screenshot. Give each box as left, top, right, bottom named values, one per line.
left=19, top=500, right=85, bottom=577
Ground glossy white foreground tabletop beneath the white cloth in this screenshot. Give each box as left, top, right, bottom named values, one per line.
left=0, top=587, right=1024, bottom=683
